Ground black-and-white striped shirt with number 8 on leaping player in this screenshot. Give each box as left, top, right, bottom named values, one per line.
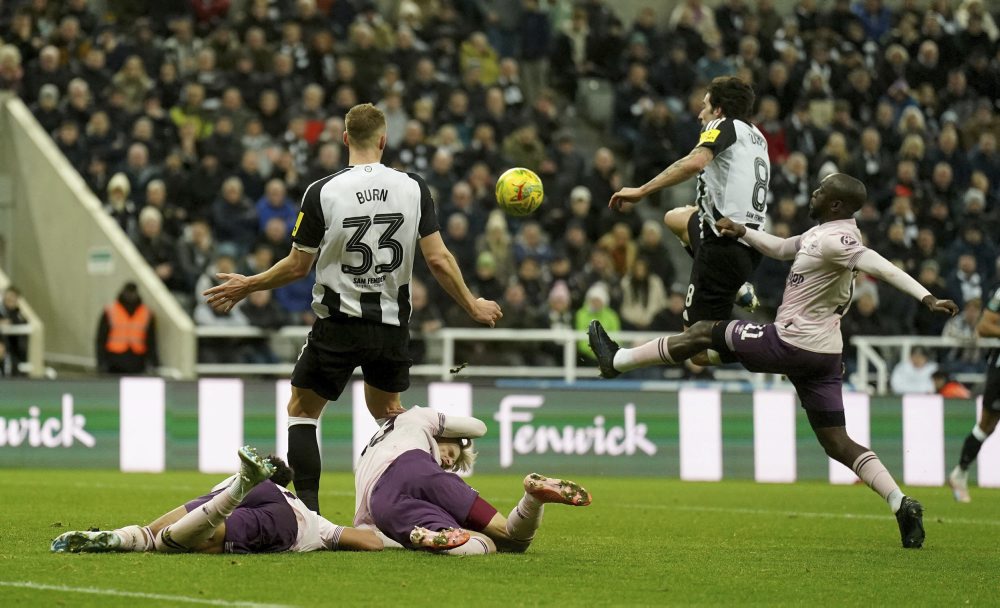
left=696, top=118, right=771, bottom=241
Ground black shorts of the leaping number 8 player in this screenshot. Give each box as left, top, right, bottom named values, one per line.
left=684, top=211, right=762, bottom=326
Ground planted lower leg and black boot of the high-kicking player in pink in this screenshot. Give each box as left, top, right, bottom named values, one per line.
left=813, top=426, right=924, bottom=549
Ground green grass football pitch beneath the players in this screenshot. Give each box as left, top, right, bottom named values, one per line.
left=0, top=470, right=1000, bottom=607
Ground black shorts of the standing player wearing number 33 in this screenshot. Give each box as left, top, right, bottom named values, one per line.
left=292, top=318, right=413, bottom=401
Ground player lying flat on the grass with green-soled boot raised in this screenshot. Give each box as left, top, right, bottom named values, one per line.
left=51, top=447, right=468, bottom=553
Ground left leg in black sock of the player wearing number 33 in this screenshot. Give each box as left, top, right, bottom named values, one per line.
left=288, top=386, right=326, bottom=513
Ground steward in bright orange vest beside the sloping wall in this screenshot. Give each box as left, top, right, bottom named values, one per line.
left=96, top=282, right=159, bottom=374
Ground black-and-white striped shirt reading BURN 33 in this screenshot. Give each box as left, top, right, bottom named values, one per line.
left=292, top=163, right=439, bottom=327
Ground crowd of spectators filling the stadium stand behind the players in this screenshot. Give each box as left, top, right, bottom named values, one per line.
left=0, top=0, right=1000, bottom=376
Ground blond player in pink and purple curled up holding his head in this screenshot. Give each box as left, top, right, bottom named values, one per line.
left=354, top=407, right=590, bottom=555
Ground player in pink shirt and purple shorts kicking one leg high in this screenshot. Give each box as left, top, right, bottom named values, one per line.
left=588, top=173, right=958, bottom=548
